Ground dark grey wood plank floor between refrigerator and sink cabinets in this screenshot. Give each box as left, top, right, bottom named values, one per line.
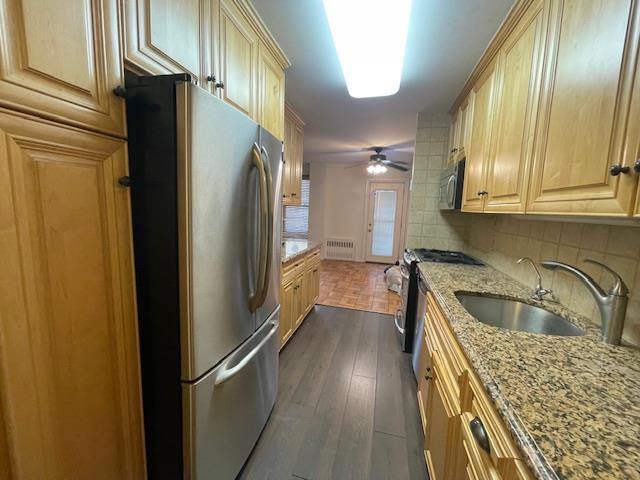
left=240, top=306, right=428, bottom=480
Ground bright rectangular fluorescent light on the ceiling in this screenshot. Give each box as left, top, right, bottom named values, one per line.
left=323, top=0, right=411, bottom=98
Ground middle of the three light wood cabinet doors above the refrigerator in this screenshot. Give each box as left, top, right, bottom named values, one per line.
left=220, top=0, right=258, bottom=118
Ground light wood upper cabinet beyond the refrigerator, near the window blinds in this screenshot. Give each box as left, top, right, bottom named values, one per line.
left=282, top=105, right=304, bottom=205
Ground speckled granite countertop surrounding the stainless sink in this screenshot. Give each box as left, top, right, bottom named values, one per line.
left=420, top=262, right=640, bottom=480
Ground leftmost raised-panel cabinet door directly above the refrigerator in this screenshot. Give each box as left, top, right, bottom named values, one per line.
left=124, top=0, right=211, bottom=84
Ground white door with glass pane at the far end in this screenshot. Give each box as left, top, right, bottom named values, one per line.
left=365, top=182, right=404, bottom=263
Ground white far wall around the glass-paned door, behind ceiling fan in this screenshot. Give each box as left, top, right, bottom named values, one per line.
left=309, top=162, right=411, bottom=262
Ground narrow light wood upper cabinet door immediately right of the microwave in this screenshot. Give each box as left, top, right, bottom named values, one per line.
left=462, top=62, right=496, bottom=212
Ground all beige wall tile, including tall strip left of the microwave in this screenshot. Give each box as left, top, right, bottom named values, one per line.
left=407, top=110, right=640, bottom=347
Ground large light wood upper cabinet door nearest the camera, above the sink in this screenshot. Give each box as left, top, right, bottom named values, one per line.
left=527, top=0, right=640, bottom=215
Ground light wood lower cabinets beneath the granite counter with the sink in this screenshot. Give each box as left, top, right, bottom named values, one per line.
left=418, top=294, right=531, bottom=480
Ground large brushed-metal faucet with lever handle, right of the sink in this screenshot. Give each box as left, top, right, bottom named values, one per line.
left=541, top=260, right=629, bottom=345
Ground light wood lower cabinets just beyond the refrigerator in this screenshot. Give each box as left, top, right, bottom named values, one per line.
left=280, top=249, right=320, bottom=348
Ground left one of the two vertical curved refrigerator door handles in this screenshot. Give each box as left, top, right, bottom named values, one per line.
left=249, top=144, right=269, bottom=312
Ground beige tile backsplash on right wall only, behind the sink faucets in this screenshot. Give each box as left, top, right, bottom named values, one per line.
left=460, top=213, right=640, bottom=346
